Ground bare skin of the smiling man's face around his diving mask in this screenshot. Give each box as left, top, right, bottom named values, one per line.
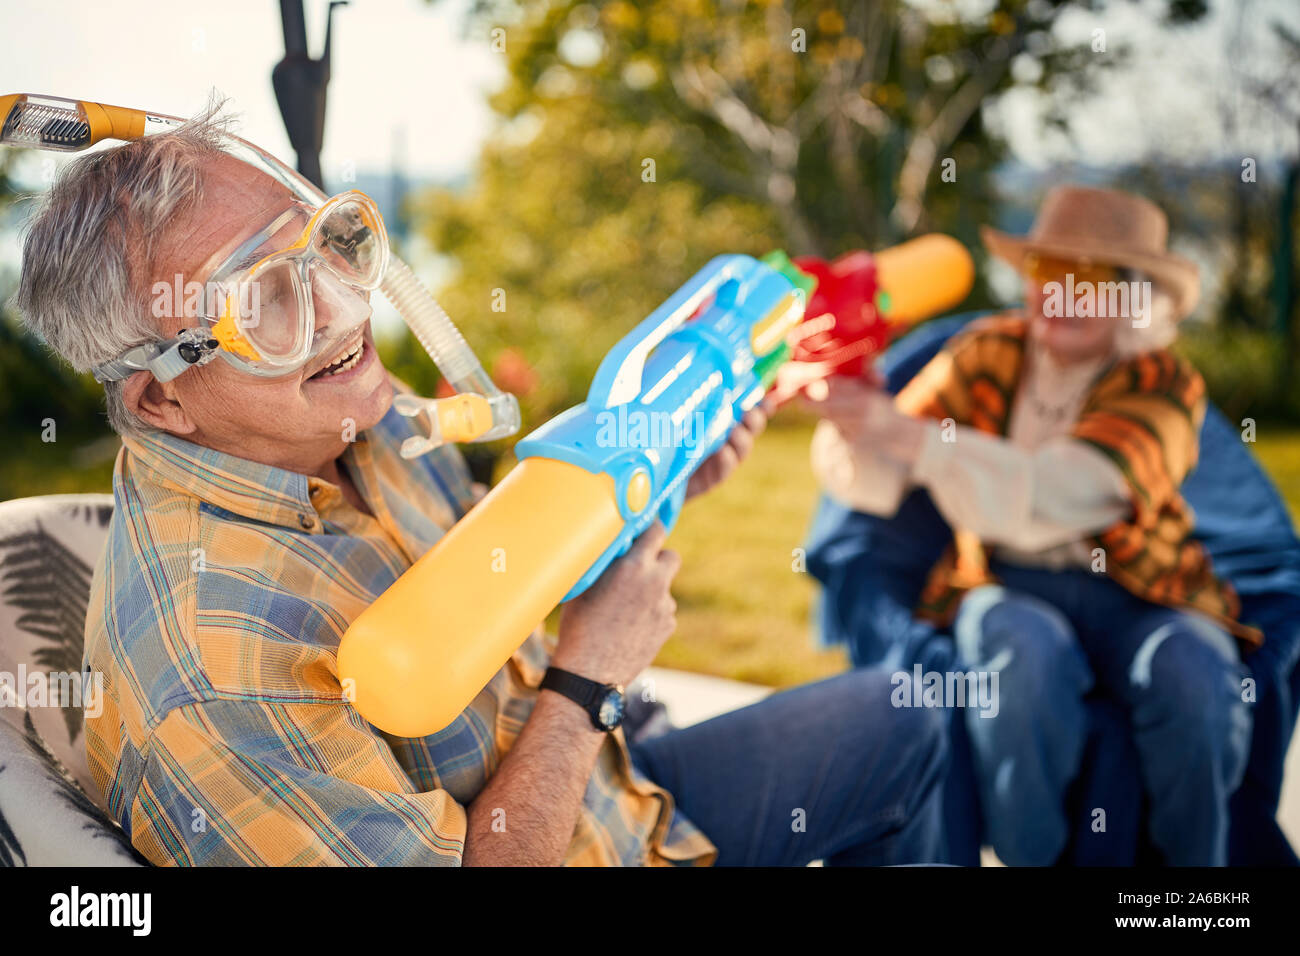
left=126, top=156, right=393, bottom=473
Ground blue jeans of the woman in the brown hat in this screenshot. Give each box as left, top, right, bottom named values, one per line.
left=954, top=563, right=1251, bottom=865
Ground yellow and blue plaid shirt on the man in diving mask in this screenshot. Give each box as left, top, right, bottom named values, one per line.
left=85, top=395, right=714, bottom=865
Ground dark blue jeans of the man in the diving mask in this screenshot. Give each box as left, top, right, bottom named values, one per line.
left=632, top=669, right=948, bottom=866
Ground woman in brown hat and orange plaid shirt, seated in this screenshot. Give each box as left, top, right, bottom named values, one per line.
left=813, top=187, right=1262, bottom=865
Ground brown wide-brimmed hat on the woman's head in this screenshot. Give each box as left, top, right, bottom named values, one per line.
left=980, top=186, right=1201, bottom=319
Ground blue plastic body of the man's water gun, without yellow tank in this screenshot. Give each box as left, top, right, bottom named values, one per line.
left=515, top=252, right=813, bottom=601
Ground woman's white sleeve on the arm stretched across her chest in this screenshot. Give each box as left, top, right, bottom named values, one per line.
left=911, top=427, right=1132, bottom=551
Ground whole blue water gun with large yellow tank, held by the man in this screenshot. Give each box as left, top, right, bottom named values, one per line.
left=338, top=252, right=814, bottom=736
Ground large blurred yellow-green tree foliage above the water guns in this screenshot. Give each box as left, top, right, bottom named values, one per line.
left=397, top=0, right=1204, bottom=427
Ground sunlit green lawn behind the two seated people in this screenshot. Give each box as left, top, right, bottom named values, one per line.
left=15, top=412, right=1300, bottom=687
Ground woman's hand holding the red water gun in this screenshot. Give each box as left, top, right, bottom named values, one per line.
left=803, top=369, right=932, bottom=466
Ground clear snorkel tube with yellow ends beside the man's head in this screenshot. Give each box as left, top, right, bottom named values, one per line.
left=0, top=94, right=520, bottom=458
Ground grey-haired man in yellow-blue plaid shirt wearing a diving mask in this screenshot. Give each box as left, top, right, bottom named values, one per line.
left=20, top=120, right=945, bottom=865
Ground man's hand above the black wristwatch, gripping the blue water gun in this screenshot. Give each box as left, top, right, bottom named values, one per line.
left=551, top=522, right=681, bottom=684
